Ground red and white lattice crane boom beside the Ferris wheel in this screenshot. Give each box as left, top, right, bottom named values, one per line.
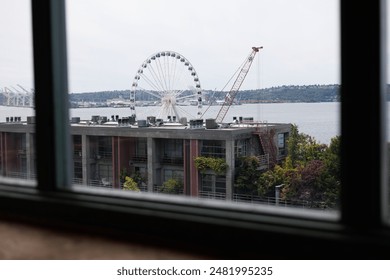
left=215, top=47, right=263, bottom=123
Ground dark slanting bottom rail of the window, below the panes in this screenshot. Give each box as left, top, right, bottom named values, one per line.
left=0, top=185, right=390, bottom=259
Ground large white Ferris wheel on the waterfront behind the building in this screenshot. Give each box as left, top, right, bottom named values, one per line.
left=130, top=51, right=203, bottom=121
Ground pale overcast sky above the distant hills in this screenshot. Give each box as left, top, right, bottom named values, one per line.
left=0, top=0, right=340, bottom=92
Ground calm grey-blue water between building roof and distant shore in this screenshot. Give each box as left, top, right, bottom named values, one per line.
left=0, top=102, right=344, bottom=144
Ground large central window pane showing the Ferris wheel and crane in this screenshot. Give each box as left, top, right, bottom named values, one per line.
left=66, top=0, right=340, bottom=210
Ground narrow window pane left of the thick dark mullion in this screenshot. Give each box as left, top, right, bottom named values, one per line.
left=0, top=0, right=36, bottom=183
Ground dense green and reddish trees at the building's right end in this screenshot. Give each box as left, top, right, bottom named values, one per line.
left=257, top=125, right=340, bottom=207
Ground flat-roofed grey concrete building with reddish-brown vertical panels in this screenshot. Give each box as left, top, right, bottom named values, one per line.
left=0, top=116, right=291, bottom=200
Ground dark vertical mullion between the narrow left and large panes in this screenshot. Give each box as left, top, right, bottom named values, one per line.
left=32, top=0, right=71, bottom=189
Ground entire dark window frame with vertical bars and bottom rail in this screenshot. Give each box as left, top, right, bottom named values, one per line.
left=0, top=0, right=390, bottom=259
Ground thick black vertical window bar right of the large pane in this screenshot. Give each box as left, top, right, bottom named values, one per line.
left=341, top=0, right=387, bottom=228
